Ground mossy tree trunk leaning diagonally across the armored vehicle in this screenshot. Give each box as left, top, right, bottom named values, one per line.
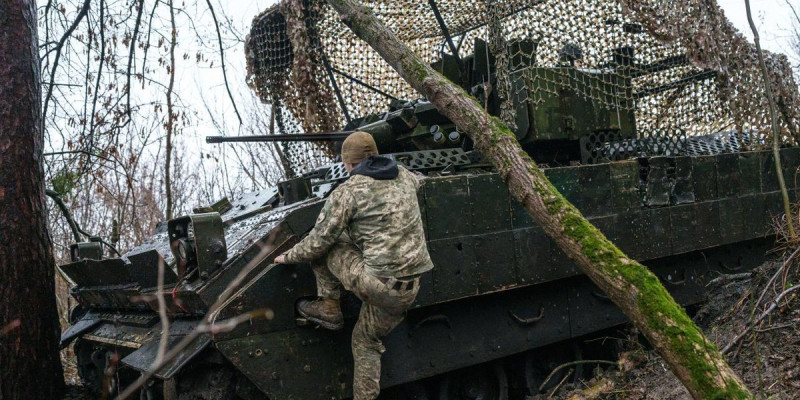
left=328, top=0, right=753, bottom=399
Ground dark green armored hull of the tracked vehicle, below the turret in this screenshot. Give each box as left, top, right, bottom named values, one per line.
left=65, top=148, right=788, bottom=399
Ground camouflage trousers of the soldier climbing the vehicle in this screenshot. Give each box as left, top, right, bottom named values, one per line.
left=313, top=241, right=419, bottom=400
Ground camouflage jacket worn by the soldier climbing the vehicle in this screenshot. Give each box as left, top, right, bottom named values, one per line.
left=286, top=162, right=433, bottom=278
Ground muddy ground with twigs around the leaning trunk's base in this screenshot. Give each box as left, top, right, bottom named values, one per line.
left=544, top=262, right=800, bottom=400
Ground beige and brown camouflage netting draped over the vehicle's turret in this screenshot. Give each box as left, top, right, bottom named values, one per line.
left=247, top=0, right=800, bottom=173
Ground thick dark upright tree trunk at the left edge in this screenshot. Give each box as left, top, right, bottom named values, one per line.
left=0, top=0, right=64, bottom=400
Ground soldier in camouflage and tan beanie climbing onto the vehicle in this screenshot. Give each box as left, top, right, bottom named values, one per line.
left=275, top=132, right=433, bottom=400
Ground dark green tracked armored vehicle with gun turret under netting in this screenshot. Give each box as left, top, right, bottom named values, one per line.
left=60, top=1, right=800, bottom=399
